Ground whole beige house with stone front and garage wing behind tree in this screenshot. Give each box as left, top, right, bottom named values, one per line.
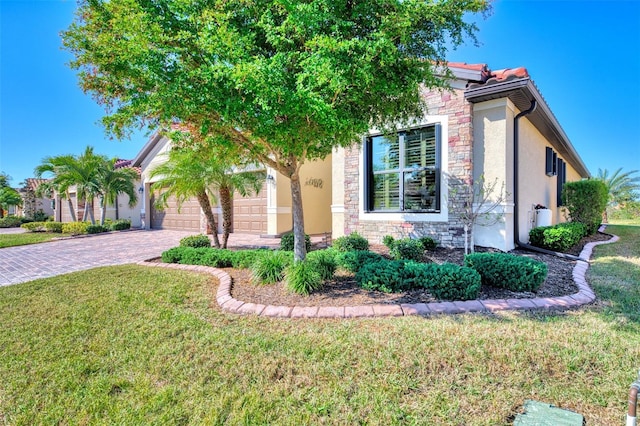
left=132, top=63, right=590, bottom=251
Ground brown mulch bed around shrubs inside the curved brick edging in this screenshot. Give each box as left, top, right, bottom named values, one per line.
left=225, top=233, right=611, bottom=306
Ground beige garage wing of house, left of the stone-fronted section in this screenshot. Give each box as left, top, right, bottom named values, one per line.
left=133, top=133, right=332, bottom=235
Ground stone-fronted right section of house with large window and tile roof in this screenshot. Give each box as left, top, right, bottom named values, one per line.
left=332, top=63, right=589, bottom=251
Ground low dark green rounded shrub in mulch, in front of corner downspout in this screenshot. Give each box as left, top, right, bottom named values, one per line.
left=464, top=253, right=547, bottom=291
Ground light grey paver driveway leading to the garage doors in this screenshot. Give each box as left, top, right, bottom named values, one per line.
left=0, top=230, right=279, bottom=286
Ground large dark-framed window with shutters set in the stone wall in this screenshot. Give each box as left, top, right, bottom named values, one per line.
left=364, top=125, right=440, bottom=213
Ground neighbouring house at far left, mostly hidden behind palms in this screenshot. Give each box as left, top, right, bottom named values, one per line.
left=54, top=159, right=143, bottom=228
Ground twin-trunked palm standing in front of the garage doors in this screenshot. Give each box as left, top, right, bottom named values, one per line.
left=151, top=148, right=262, bottom=248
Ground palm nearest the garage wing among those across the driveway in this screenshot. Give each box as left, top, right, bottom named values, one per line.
left=96, top=158, right=138, bottom=225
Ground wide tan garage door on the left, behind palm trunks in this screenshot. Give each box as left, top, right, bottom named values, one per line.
left=151, top=193, right=200, bottom=232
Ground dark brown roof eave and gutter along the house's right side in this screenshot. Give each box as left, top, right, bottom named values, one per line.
left=465, top=78, right=591, bottom=178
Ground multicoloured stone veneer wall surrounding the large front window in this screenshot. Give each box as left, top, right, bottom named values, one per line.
left=344, top=85, right=473, bottom=247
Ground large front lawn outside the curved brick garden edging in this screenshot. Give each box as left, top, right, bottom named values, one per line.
left=0, top=225, right=640, bottom=425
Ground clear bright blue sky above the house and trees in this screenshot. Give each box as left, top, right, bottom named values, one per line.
left=0, top=0, right=640, bottom=186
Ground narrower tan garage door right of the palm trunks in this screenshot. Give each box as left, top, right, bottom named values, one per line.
left=233, top=182, right=267, bottom=234
